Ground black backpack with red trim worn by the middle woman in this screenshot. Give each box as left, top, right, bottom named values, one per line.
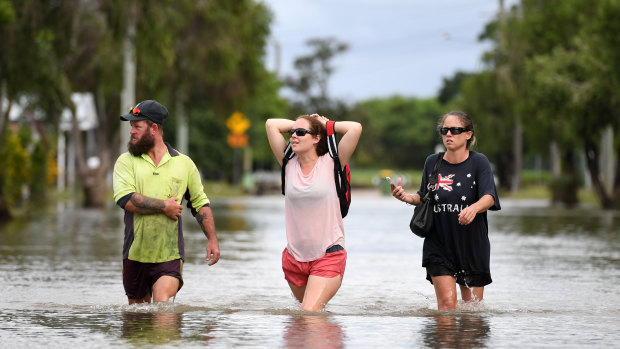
left=282, top=121, right=351, bottom=218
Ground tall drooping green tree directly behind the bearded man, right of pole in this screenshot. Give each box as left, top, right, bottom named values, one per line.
left=124, top=0, right=282, bottom=179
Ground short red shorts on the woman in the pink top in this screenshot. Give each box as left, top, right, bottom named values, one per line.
left=282, top=248, right=347, bottom=287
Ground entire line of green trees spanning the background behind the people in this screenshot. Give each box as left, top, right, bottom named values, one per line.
left=0, top=0, right=620, bottom=217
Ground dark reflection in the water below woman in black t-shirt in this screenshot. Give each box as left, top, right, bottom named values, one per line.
left=422, top=314, right=491, bottom=348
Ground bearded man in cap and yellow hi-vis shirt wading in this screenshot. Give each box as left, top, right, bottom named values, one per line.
left=113, top=100, right=220, bottom=304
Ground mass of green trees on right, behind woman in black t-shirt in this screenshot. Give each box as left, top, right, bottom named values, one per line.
left=452, top=0, right=620, bottom=208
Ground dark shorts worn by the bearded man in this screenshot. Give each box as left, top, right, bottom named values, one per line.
left=123, top=259, right=183, bottom=299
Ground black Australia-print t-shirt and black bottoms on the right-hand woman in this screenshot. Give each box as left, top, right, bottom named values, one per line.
left=418, top=151, right=501, bottom=286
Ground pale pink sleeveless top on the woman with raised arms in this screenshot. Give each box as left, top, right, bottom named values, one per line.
left=284, top=154, right=344, bottom=262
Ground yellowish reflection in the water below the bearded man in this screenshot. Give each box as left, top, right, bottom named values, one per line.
left=121, top=312, right=181, bottom=345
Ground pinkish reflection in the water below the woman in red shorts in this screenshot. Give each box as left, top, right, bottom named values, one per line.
left=283, top=314, right=345, bottom=349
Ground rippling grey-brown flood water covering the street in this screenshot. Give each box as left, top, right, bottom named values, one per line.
left=0, top=190, right=620, bottom=348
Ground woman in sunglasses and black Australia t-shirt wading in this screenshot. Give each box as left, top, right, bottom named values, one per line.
left=392, top=111, right=500, bottom=310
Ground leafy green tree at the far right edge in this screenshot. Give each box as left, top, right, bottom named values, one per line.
left=527, top=0, right=620, bottom=208
